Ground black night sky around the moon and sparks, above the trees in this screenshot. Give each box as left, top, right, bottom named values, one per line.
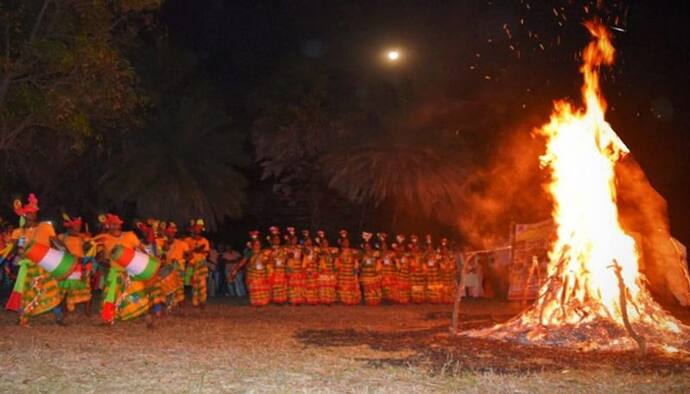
left=162, top=0, right=690, bottom=245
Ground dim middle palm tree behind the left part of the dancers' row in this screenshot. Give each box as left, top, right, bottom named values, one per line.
left=252, top=59, right=350, bottom=227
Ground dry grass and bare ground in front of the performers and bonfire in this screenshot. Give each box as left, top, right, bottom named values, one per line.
left=0, top=301, right=690, bottom=393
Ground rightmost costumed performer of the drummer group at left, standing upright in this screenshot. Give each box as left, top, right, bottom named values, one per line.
left=185, top=219, right=211, bottom=306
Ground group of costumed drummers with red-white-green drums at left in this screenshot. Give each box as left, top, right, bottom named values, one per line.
left=0, top=194, right=210, bottom=325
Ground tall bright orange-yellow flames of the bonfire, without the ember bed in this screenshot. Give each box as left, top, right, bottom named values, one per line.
left=537, top=22, right=676, bottom=327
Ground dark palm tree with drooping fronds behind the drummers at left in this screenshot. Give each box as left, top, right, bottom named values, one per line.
left=101, top=95, right=247, bottom=229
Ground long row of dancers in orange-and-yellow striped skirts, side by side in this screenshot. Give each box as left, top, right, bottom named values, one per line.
left=231, top=227, right=457, bottom=306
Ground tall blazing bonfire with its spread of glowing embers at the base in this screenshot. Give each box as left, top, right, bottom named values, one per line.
left=466, top=22, right=690, bottom=352
